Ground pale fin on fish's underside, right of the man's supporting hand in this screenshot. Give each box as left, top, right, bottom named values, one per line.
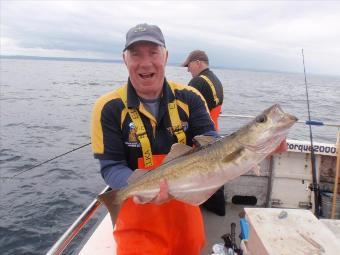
left=171, top=186, right=220, bottom=205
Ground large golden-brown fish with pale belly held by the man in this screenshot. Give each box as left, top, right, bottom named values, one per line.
left=98, top=105, right=297, bottom=220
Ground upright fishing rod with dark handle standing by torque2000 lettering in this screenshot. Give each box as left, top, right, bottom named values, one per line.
left=301, top=49, right=321, bottom=218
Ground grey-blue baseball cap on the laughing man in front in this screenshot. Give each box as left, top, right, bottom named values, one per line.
left=123, top=23, right=165, bottom=51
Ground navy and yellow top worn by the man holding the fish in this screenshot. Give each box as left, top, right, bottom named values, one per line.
left=91, top=80, right=214, bottom=169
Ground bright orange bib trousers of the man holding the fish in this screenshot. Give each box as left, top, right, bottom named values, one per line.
left=113, top=155, right=205, bottom=255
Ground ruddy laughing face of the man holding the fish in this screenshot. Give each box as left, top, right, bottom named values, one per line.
left=123, top=42, right=168, bottom=99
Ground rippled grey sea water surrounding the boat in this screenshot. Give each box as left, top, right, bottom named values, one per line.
left=0, top=59, right=340, bottom=255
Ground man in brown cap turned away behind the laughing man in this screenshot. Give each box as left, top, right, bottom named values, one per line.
left=182, top=50, right=225, bottom=216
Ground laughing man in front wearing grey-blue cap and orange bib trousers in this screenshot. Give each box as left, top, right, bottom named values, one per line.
left=91, top=24, right=217, bottom=255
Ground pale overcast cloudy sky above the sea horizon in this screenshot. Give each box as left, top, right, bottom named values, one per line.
left=0, top=0, right=340, bottom=75
